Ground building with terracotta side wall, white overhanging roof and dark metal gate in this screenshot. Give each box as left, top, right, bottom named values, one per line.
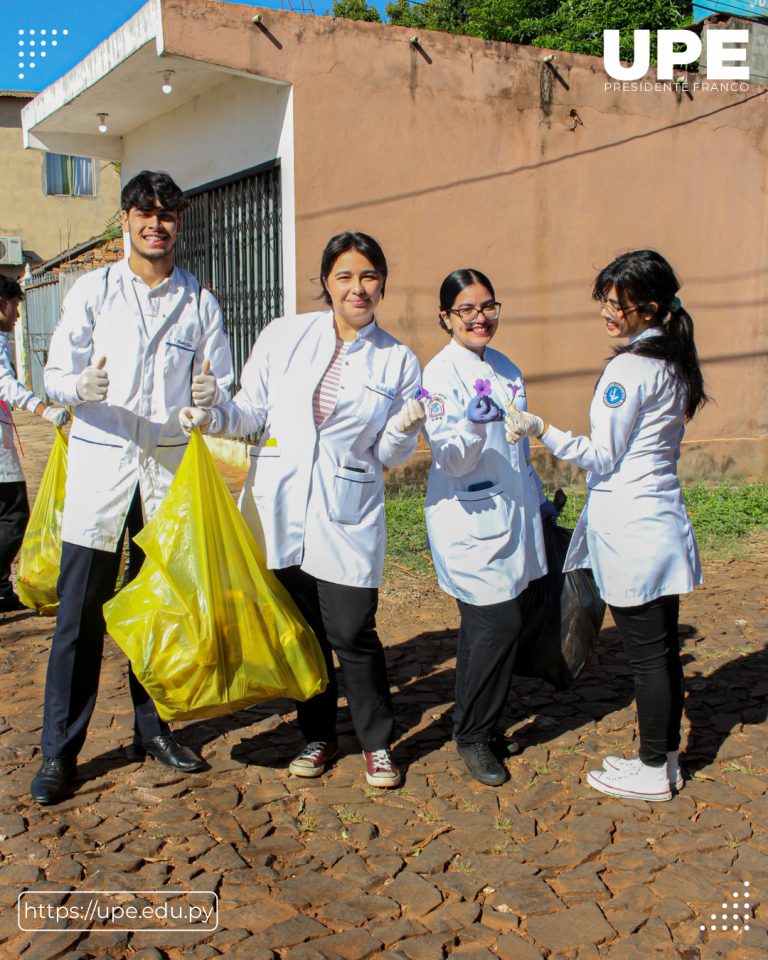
left=18, top=0, right=768, bottom=482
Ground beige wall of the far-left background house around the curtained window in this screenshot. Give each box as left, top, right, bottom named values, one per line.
left=0, top=97, right=120, bottom=276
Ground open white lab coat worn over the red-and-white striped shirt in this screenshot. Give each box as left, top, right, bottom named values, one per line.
left=210, top=311, right=419, bottom=587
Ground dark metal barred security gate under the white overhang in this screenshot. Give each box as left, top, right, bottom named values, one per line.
left=175, top=160, right=283, bottom=386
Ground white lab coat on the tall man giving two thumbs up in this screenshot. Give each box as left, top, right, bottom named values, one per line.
left=45, top=260, right=233, bottom=552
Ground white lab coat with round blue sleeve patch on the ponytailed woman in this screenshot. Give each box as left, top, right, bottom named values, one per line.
left=541, top=330, right=702, bottom=607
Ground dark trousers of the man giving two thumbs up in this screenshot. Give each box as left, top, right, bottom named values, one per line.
left=40, top=486, right=170, bottom=757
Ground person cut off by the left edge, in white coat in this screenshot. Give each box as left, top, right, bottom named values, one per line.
left=0, top=274, right=69, bottom=613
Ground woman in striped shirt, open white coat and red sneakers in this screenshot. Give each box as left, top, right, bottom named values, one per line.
left=179, top=232, right=424, bottom=787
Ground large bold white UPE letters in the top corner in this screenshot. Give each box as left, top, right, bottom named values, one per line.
left=603, top=30, right=749, bottom=80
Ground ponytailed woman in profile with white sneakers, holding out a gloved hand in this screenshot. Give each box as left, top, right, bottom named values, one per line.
left=510, top=250, right=709, bottom=800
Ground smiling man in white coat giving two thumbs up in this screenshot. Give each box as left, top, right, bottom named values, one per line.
left=32, top=170, right=233, bottom=803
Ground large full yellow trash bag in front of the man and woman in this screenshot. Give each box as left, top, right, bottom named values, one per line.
left=104, top=430, right=328, bottom=720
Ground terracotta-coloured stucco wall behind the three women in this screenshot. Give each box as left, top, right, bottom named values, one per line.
left=153, top=0, right=768, bottom=478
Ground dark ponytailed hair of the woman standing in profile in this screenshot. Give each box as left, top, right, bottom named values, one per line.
left=592, top=250, right=710, bottom=421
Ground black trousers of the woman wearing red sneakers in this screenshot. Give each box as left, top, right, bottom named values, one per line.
left=273, top=567, right=395, bottom=751
